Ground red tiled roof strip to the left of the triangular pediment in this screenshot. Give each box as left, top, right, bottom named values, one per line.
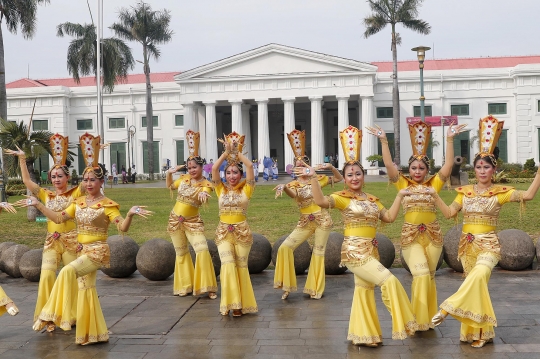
left=6, top=72, right=179, bottom=89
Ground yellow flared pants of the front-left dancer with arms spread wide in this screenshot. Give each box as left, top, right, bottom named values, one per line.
left=39, top=255, right=109, bottom=344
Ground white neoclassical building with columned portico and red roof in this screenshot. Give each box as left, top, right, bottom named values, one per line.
left=7, top=44, right=540, bottom=173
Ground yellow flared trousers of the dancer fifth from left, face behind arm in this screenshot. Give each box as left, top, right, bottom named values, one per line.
left=274, top=225, right=330, bottom=299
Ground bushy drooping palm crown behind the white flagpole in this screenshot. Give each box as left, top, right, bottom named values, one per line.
left=56, top=22, right=135, bottom=92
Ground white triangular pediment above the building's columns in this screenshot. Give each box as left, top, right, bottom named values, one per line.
left=175, top=44, right=377, bottom=81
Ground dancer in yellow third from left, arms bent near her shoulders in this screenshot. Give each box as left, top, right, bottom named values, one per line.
left=166, top=130, right=217, bottom=299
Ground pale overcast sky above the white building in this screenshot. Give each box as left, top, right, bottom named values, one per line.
left=1, top=0, right=540, bottom=82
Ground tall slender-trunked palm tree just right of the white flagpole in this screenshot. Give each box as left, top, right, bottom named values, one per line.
left=110, top=2, right=173, bottom=180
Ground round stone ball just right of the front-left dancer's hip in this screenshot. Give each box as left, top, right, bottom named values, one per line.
left=101, top=235, right=139, bottom=278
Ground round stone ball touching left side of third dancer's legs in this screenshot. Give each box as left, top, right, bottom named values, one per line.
left=136, top=238, right=176, bottom=281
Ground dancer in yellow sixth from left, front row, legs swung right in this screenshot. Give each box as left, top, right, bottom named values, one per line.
left=298, top=126, right=417, bottom=347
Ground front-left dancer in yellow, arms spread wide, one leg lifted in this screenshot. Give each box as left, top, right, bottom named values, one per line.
left=19, top=133, right=150, bottom=345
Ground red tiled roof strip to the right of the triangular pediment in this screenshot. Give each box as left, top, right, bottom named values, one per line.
left=371, top=56, right=540, bottom=72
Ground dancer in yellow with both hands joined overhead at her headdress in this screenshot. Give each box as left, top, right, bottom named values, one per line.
left=212, top=132, right=258, bottom=317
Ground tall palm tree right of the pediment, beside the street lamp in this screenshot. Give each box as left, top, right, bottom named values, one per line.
left=364, top=0, right=431, bottom=165
